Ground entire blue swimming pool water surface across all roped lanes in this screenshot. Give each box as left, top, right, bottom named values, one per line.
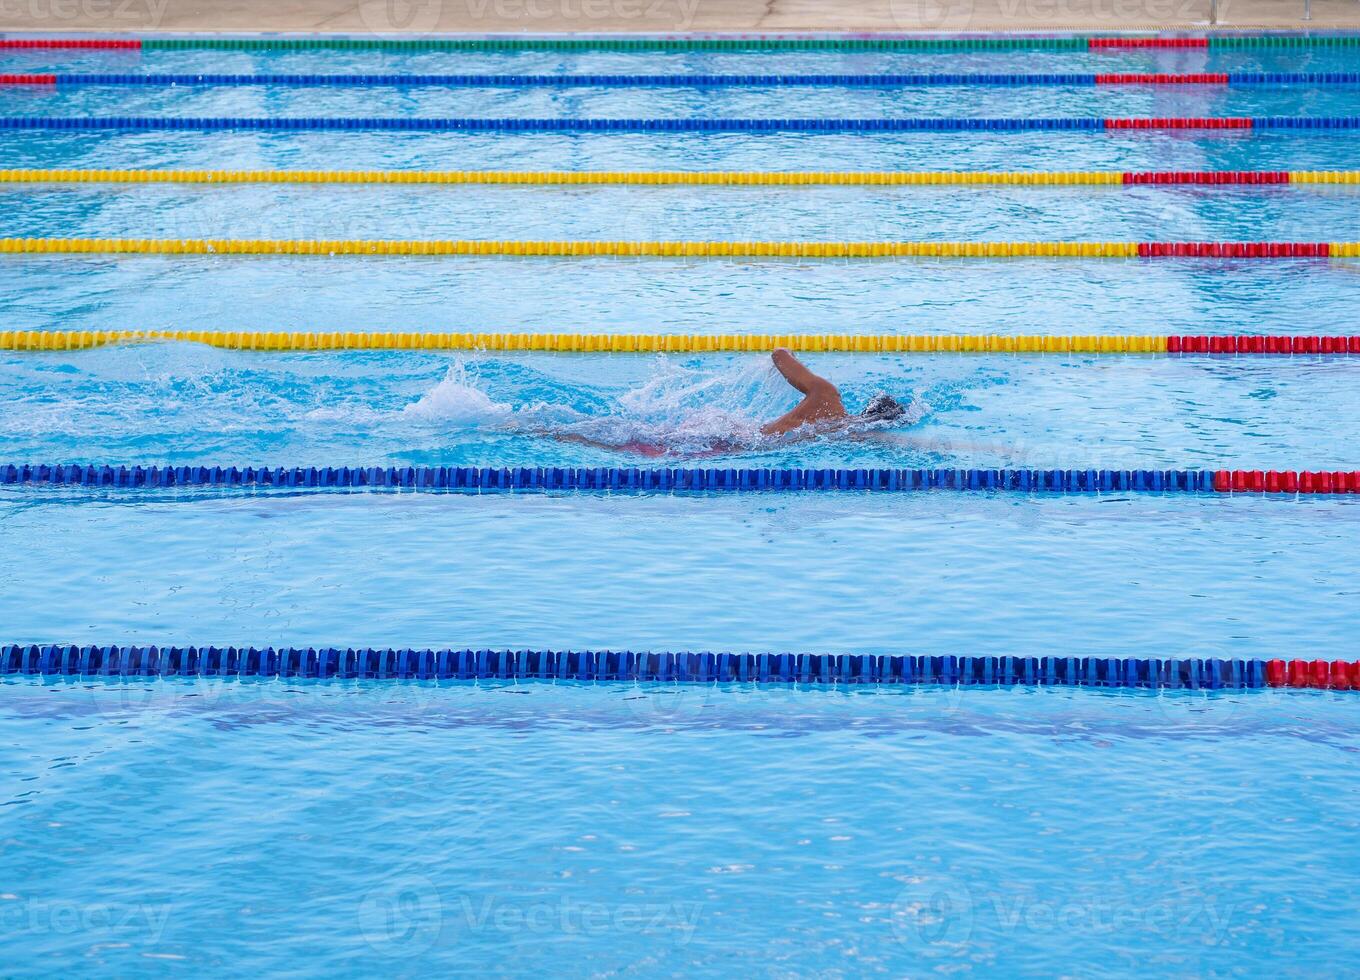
left=0, top=32, right=1360, bottom=976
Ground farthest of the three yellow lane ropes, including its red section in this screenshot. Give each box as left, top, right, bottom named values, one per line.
left=0, top=169, right=1360, bottom=186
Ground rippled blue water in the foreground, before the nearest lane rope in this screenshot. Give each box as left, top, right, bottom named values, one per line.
left=0, top=681, right=1360, bottom=976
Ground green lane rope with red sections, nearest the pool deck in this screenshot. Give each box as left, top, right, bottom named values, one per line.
left=0, top=33, right=1360, bottom=52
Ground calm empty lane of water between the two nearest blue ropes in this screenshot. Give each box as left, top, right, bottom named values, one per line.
left=0, top=491, right=1360, bottom=659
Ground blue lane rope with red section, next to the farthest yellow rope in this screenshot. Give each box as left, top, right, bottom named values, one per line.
left=0, top=116, right=1360, bottom=133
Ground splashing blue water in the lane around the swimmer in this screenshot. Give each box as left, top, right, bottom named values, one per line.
left=0, top=344, right=1360, bottom=467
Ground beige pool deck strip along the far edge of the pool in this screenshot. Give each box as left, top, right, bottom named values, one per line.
left=0, top=0, right=1360, bottom=35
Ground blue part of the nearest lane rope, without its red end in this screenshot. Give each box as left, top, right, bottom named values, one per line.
left=0, top=644, right=1268, bottom=690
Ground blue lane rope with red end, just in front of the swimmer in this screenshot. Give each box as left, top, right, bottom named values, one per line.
left=0, top=463, right=1360, bottom=495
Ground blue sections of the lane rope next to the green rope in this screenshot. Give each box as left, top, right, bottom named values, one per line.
left=23, top=72, right=1360, bottom=88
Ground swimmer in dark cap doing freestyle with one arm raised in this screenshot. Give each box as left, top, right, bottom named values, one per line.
left=555, top=347, right=907, bottom=458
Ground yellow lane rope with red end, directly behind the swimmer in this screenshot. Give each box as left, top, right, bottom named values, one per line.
left=0, top=330, right=1360, bottom=355
